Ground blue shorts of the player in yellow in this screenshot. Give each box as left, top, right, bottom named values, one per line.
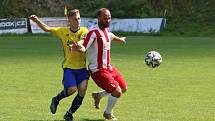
left=62, top=68, right=90, bottom=89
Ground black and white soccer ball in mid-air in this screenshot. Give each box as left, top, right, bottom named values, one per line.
left=145, top=51, right=162, bottom=68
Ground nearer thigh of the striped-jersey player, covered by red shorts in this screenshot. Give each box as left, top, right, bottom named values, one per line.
left=91, top=69, right=119, bottom=93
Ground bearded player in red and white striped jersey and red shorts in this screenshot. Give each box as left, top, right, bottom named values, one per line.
left=73, top=8, right=127, bottom=120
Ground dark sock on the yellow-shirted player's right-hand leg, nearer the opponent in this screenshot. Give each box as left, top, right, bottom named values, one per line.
left=69, top=94, right=84, bottom=113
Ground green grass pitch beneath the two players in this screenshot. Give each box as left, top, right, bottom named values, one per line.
left=0, top=35, right=215, bottom=121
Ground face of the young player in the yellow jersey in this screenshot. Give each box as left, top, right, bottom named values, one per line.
left=69, top=13, right=81, bottom=29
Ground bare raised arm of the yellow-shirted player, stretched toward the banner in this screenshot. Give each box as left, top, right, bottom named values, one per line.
left=29, top=15, right=51, bottom=32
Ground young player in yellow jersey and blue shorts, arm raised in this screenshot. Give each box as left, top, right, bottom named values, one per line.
left=30, top=9, right=89, bottom=121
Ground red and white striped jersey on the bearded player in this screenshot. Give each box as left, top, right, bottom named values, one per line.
left=83, top=27, right=115, bottom=72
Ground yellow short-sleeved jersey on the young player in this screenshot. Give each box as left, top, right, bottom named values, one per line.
left=51, top=27, right=88, bottom=69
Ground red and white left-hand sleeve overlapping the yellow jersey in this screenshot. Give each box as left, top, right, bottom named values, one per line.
left=83, top=31, right=96, bottom=50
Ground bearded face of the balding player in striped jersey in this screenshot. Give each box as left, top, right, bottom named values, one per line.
left=98, top=10, right=111, bottom=28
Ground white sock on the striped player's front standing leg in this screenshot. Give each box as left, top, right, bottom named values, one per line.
left=105, top=95, right=118, bottom=113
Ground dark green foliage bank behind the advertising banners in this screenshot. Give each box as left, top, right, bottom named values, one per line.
left=0, top=0, right=215, bottom=36
